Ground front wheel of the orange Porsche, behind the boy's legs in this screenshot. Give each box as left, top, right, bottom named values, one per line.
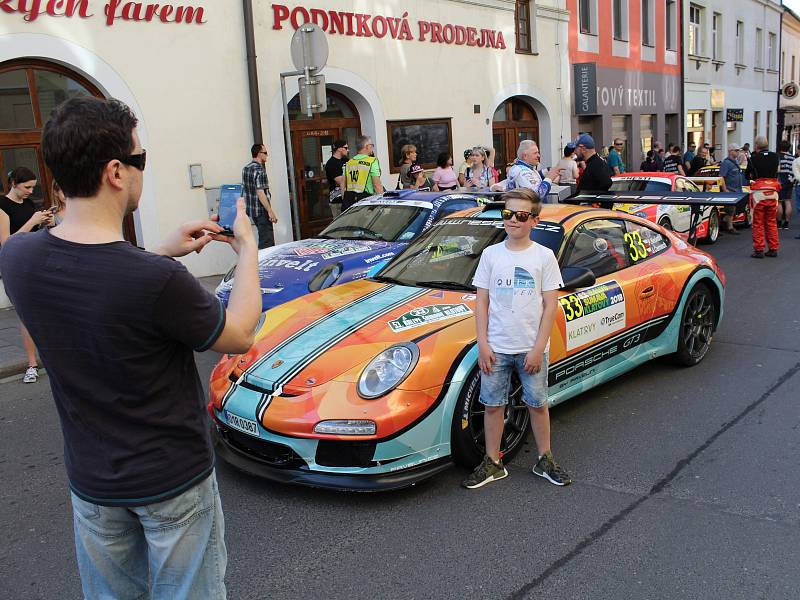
left=450, top=369, right=530, bottom=469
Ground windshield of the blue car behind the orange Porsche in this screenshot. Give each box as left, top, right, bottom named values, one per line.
left=319, top=204, right=430, bottom=242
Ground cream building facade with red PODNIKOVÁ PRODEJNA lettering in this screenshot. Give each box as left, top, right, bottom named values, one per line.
left=0, top=0, right=571, bottom=308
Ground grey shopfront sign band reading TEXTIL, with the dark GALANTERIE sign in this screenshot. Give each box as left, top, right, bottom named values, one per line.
left=573, top=63, right=681, bottom=115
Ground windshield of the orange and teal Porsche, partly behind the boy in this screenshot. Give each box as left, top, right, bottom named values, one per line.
left=374, top=218, right=563, bottom=290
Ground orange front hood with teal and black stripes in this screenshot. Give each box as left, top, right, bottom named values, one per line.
left=236, top=280, right=475, bottom=394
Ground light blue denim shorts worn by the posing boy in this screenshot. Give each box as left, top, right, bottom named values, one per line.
left=480, top=352, right=548, bottom=408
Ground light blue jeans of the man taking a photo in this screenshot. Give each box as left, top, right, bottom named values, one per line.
left=71, top=472, right=228, bottom=600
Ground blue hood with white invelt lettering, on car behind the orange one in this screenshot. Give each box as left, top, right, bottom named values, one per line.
left=216, top=238, right=406, bottom=310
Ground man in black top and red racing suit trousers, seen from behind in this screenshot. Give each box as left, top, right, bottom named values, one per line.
left=749, top=135, right=781, bottom=258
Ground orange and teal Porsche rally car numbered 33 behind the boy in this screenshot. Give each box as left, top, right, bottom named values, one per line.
left=208, top=203, right=725, bottom=490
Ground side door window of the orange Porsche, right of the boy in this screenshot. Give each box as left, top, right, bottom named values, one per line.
left=561, top=219, right=630, bottom=277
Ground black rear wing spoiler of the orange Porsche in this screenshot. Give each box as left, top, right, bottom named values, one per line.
left=564, top=193, right=749, bottom=245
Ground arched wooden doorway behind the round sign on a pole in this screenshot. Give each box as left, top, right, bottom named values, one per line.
left=289, top=88, right=361, bottom=238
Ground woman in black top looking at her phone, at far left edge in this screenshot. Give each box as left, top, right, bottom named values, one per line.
left=0, top=167, right=52, bottom=383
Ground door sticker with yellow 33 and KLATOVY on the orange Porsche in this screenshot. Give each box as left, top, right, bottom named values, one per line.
left=558, top=281, right=625, bottom=351
